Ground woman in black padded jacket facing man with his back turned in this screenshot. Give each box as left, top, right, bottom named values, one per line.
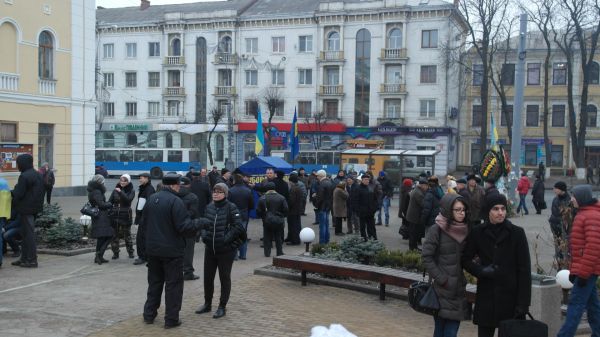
left=196, top=183, right=247, bottom=318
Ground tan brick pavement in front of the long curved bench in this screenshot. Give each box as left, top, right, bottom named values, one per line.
left=90, top=275, right=476, bottom=337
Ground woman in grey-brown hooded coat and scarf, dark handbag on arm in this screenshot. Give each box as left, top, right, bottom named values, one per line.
left=422, top=193, right=471, bottom=337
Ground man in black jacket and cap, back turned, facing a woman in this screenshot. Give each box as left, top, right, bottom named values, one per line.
left=143, top=173, right=200, bottom=329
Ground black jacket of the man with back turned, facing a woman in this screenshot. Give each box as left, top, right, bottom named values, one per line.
left=142, top=188, right=200, bottom=258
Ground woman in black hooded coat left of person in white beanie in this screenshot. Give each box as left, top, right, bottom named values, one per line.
left=87, top=174, right=115, bottom=264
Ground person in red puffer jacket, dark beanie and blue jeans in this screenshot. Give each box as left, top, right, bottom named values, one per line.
left=557, top=185, right=600, bottom=337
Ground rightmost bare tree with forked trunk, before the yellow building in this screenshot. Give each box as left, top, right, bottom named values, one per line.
left=551, top=0, right=600, bottom=168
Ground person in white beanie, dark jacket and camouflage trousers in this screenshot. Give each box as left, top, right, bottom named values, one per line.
left=108, top=169, right=135, bottom=260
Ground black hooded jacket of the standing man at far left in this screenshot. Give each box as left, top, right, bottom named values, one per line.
left=11, top=154, right=44, bottom=215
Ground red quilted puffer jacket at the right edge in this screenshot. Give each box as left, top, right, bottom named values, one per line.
left=570, top=202, right=600, bottom=279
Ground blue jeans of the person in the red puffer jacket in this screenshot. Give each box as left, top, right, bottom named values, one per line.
left=556, top=275, right=600, bottom=337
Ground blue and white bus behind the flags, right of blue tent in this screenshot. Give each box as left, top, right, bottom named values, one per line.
left=271, top=150, right=340, bottom=175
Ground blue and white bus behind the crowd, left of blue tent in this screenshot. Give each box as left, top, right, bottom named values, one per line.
left=96, top=148, right=200, bottom=179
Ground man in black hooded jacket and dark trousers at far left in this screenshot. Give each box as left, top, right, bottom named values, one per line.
left=11, top=153, right=44, bottom=268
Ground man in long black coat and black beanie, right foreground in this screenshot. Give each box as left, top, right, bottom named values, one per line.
left=461, top=194, right=531, bottom=337
